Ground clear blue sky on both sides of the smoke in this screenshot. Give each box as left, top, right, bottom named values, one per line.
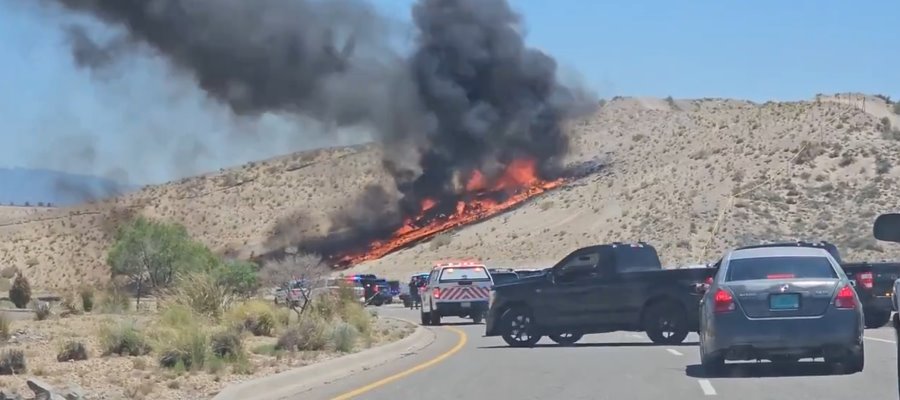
left=0, top=0, right=900, bottom=183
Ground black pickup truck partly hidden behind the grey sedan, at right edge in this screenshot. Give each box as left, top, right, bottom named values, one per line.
left=736, top=241, right=900, bottom=329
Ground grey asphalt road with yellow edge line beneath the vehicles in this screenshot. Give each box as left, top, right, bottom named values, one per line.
left=298, top=306, right=897, bottom=400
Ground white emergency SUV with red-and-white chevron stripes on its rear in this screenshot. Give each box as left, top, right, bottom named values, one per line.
left=419, top=260, right=494, bottom=325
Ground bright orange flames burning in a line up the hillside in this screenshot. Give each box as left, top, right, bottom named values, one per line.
left=338, top=159, right=564, bottom=265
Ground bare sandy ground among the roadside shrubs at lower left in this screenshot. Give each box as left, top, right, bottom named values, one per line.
left=0, top=315, right=415, bottom=400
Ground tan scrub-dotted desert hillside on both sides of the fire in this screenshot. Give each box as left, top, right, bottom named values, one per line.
left=0, top=94, right=900, bottom=288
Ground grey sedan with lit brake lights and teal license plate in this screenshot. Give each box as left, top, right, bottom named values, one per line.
left=700, top=246, right=865, bottom=373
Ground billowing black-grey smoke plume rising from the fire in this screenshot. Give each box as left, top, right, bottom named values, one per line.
left=44, top=0, right=592, bottom=260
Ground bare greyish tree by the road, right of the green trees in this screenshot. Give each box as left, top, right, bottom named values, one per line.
left=259, top=248, right=329, bottom=317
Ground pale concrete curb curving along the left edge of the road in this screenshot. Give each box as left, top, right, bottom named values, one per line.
left=213, top=317, right=436, bottom=400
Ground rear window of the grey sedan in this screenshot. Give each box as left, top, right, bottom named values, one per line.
left=725, top=257, right=838, bottom=282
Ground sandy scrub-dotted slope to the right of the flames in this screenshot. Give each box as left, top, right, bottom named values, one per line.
left=354, top=95, right=900, bottom=277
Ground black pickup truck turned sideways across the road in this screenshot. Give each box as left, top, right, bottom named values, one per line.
left=485, top=242, right=715, bottom=347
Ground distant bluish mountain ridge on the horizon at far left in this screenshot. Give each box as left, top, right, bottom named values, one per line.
left=0, top=168, right=140, bottom=206
